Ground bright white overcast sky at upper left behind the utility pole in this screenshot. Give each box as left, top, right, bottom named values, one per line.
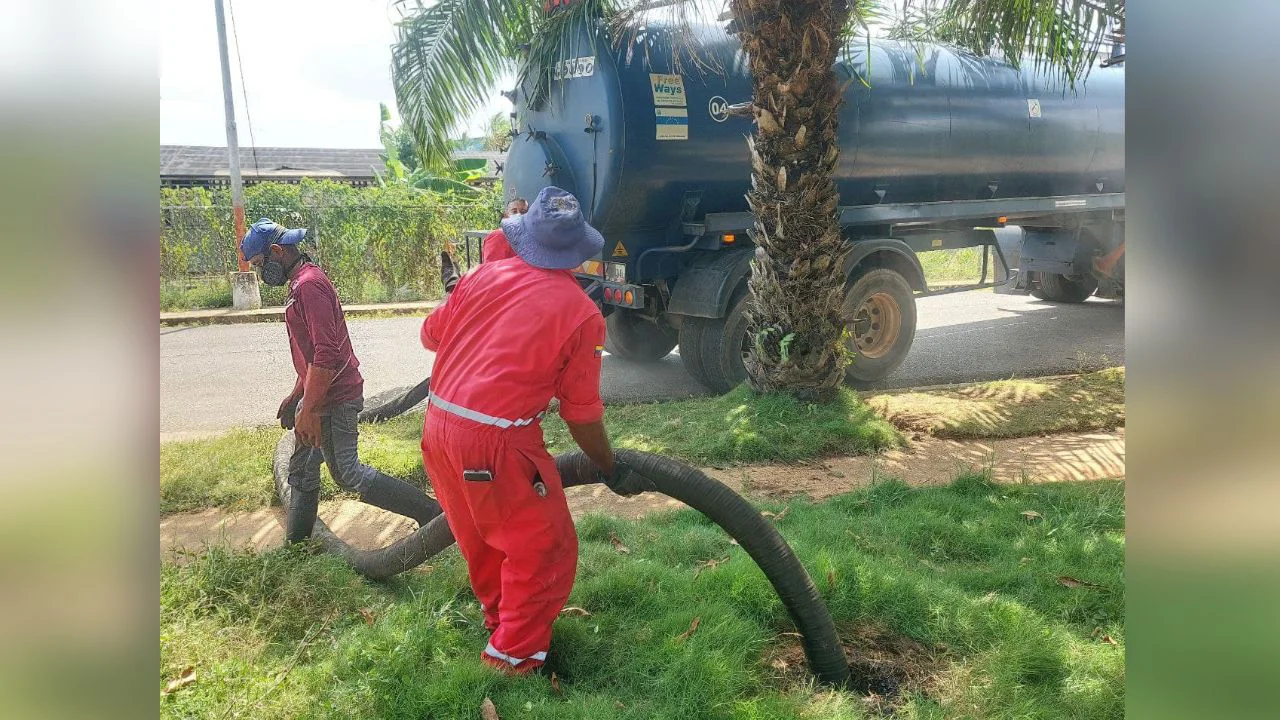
left=159, top=0, right=511, bottom=147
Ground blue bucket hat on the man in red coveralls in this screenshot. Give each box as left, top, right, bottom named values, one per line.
left=502, top=186, right=604, bottom=270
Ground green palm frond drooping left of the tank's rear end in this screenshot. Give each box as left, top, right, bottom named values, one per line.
left=392, top=0, right=541, bottom=167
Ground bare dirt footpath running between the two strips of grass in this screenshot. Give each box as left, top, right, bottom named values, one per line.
left=160, top=428, right=1125, bottom=555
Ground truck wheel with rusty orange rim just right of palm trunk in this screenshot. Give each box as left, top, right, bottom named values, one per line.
left=844, top=268, right=915, bottom=386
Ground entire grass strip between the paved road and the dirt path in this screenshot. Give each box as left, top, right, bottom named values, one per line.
left=160, top=368, right=1125, bottom=514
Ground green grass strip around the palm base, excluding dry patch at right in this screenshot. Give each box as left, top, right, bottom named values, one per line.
left=160, top=387, right=899, bottom=512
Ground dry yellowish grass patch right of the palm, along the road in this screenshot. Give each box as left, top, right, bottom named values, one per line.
left=867, top=368, right=1125, bottom=438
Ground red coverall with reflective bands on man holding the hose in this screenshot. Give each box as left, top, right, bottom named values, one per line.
left=421, top=258, right=604, bottom=671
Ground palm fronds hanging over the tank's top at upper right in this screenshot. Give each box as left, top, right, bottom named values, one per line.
left=888, top=0, right=1125, bottom=86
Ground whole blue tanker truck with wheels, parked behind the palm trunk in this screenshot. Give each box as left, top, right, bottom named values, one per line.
left=504, top=19, right=1125, bottom=392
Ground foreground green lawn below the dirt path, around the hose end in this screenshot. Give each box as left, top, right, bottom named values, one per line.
left=159, top=475, right=1125, bottom=720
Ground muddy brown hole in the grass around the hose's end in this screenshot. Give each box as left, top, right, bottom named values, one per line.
left=763, top=625, right=946, bottom=716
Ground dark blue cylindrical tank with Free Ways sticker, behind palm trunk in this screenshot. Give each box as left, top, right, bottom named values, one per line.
left=506, top=18, right=1124, bottom=245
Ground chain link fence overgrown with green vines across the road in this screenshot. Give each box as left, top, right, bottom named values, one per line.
left=160, top=192, right=498, bottom=310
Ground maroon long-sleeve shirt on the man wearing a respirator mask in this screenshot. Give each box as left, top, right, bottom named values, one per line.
left=284, top=263, right=365, bottom=411
